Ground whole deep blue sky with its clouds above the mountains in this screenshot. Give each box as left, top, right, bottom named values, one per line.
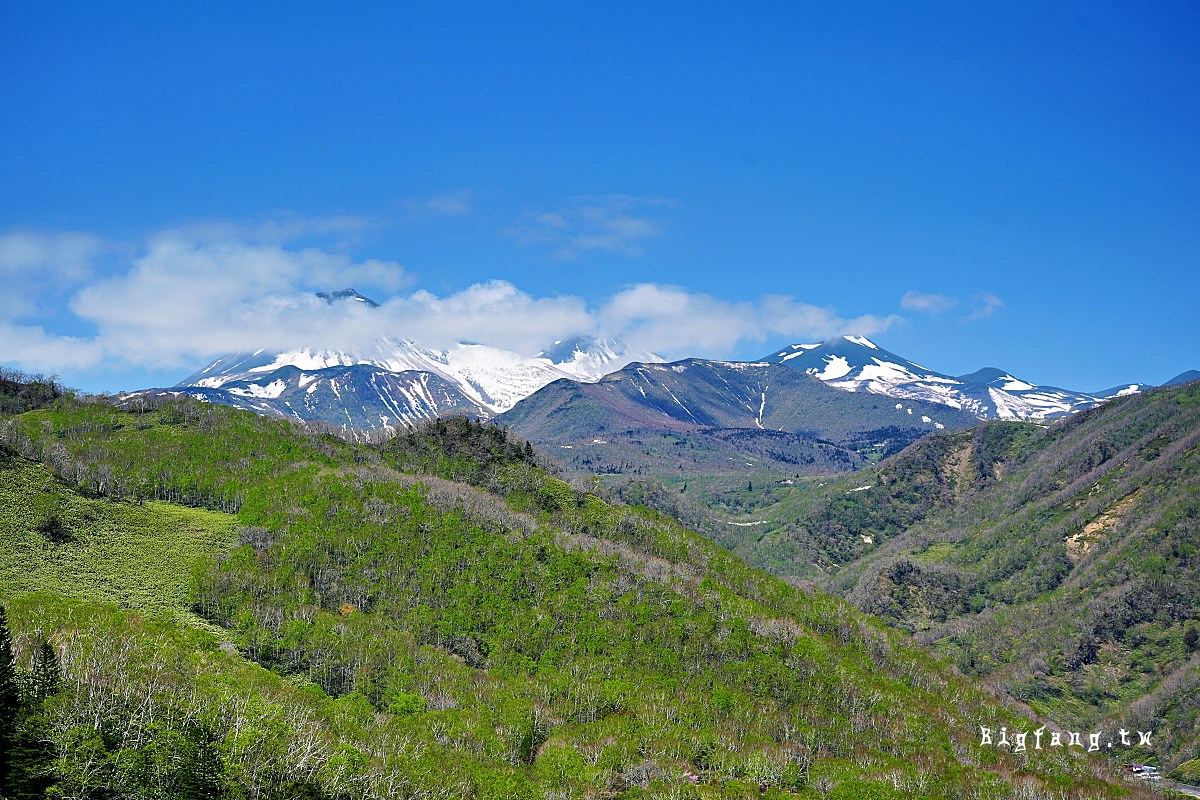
left=0, top=0, right=1200, bottom=391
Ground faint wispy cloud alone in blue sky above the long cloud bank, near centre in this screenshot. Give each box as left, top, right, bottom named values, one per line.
left=510, top=194, right=674, bottom=260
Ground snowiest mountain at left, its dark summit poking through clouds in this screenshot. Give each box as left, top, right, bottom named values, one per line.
left=173, top=289, right=661, bottom=428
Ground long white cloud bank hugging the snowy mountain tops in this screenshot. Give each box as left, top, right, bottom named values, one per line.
left=0, top=221, right=899, bottom=383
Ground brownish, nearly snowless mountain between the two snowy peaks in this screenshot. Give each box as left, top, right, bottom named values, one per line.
left=497, top=359, right=978, bottom=477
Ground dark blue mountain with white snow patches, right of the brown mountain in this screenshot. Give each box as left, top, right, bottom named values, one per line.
left=762, top=336, right=1147, bottom=420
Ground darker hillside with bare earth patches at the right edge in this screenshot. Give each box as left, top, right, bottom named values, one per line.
left=710, top=384, right=1200, bottom=777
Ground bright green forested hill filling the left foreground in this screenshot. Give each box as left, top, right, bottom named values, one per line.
left=0, top=402, right=1161, bottom=798
